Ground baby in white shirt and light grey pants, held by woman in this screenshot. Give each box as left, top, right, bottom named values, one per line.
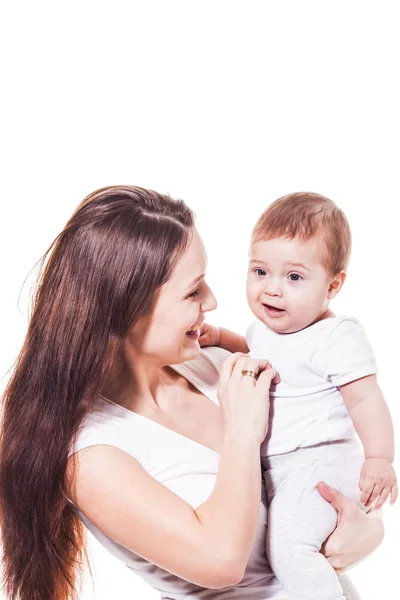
left=200, top=193, right=398, bottom=600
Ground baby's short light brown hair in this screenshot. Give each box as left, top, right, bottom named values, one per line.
left=252, top=192, right=351, bottom=275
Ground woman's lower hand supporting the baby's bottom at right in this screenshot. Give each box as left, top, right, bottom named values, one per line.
left=317, top=483, right=384, bottom=574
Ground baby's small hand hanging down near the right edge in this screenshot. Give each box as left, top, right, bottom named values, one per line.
left=359, top=458, right=398, bottom=510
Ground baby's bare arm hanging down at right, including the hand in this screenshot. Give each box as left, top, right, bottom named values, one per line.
left=339, top=375, right=398, bottom=509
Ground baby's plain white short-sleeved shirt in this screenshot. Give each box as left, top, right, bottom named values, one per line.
left=246, top=316, right=377, bottom=456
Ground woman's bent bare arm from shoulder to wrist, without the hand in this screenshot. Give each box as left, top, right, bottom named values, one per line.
left=69, top=442, right=261, bottom=588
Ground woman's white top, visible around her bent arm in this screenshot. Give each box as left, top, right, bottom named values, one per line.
left=69, top=347, right=288, bottom=600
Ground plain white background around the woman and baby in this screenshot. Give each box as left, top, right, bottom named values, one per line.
left=0, top=0, right=400, bottom=600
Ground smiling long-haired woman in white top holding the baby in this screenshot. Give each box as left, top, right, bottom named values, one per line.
left=0, top=187, right=382, bottom=600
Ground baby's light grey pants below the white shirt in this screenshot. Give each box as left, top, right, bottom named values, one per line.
left=261, top=439, right=364, bottom=600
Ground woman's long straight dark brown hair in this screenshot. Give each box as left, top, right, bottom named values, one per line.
left=0, top=186, right=194, bottom=600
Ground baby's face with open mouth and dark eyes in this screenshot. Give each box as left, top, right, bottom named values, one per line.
left=247, top=237, right=334, bottom=333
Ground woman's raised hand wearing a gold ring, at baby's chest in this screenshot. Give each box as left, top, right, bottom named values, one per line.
left=218, top=352, right=280, bottom=444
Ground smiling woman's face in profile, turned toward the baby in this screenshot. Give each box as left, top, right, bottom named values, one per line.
left=129, top=228, right=217, bottom=366
